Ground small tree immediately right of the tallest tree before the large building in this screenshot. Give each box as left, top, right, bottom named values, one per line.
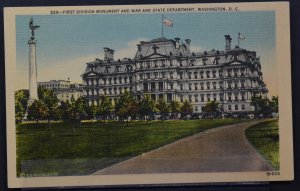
left=138, top=95, right=155, bottom=123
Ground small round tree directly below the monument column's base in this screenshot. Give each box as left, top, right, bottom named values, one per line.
left=28, top=100, right=48, bottom=125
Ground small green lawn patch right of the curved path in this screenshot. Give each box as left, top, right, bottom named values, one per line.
left=246, top=120, right=279, bottom=170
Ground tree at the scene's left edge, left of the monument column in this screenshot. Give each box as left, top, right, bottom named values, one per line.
left=15, top=90, right=29, bottom=123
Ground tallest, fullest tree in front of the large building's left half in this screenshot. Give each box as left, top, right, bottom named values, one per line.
left=115, top=91, right=138, bottom=126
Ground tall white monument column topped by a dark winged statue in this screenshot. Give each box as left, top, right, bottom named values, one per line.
left=28, top=18, right=40, bottom=105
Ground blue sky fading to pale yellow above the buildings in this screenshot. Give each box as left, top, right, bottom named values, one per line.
left=15, top=11, right=278, bottom=96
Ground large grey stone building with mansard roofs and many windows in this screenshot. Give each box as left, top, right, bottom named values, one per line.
left=82, top=35, right=268, bottom=113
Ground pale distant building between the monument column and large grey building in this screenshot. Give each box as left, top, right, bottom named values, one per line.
left=38, top=80, right=83, bottom=101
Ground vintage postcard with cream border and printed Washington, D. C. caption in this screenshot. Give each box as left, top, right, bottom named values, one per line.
left=4, top=2, right=294, bottom=188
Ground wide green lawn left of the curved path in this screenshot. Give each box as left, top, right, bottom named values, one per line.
left=17, top=119, right=241, bottom=177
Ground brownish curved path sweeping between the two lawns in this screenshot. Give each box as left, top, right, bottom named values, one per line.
left=94, top=120, right=272, bottom=175
